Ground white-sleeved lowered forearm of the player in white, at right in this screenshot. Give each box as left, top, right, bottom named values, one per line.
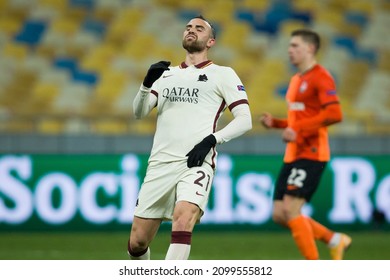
left=214, top=104, right=252, bottom=144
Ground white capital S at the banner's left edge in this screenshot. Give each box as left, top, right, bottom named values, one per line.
left=0, top=156, right=33, bottom=224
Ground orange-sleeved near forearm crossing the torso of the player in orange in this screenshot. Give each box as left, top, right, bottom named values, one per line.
left=292, top=103, right=343, bottom=132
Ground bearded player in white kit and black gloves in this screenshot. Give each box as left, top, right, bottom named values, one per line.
left=128, top=16, right=252, bottom=260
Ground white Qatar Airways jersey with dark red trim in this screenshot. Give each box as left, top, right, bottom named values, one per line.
left=149, top=61, right=248, bottom=168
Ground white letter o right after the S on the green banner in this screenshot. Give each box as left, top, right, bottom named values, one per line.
left=35, top=172, right=77, bottom=224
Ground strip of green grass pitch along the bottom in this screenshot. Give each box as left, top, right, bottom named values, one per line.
left=0, top=230, right=390, bottom=260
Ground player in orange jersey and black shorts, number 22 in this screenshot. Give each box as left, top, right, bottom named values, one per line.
left=260, top=30, right=352, bottom=260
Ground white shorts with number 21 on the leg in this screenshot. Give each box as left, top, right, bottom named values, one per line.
left=134, top=161, right=214, bottom=220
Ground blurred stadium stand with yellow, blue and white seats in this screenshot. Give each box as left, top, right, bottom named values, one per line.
left=0, top=0, right=390, bottom=135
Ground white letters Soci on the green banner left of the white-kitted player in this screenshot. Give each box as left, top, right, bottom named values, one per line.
left=0, top=155, right=139, bottom=225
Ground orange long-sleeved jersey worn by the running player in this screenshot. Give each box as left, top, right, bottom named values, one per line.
left=284, top=64, right=342, bottom=162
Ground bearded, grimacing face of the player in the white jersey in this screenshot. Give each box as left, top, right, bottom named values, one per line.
left=183, top=18, right=215, bottom=53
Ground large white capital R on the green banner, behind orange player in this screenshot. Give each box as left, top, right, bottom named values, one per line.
left=329, top=158, right=376, bottom=223
